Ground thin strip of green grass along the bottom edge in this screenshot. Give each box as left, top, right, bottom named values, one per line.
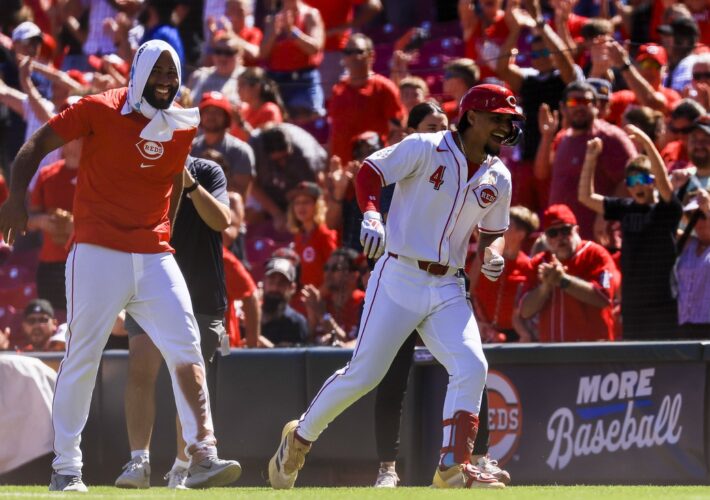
left=0, top=486, right=710, bottom=500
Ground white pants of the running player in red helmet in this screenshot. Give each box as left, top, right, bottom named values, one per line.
left=298, top=255, right=488, bottom=443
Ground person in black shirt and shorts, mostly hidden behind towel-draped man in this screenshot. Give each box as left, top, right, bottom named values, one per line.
left=115, top=156, right=231, bottom=489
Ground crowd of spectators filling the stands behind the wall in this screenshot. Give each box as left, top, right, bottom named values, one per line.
left=0, top=0, right=710, bottom=350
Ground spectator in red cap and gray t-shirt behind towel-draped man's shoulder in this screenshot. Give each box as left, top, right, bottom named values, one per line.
left=191, top=92, right=256, bottom=200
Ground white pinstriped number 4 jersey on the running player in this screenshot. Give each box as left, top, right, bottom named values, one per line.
left=365, top=132, right=511, bottom=268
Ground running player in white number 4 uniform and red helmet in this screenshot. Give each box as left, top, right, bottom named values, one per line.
left=269, top=84, right=523, bottom=489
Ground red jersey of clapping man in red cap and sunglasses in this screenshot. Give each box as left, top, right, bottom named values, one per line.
left=523, top=240, right=619, bottom=342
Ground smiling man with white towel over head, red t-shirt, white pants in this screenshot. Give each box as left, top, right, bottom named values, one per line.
left=0, top=40, right=241, bottom=492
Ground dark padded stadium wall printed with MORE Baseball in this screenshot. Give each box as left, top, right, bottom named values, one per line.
left=0, top=342, right=710, bottom=486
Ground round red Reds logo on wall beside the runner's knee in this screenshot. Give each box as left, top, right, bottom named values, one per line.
left=486, top=370, right=523, bottom=465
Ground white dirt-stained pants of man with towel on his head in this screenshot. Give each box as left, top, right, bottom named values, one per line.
left=52, top=243, right=214, bottom=475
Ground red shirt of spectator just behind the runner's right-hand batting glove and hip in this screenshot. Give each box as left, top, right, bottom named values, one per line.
left=473, top=252, right=530, bottom=330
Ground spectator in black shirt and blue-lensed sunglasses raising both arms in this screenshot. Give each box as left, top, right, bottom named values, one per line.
left=578, top=125, right=683, bottom=340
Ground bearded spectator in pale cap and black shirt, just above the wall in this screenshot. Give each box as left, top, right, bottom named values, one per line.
left=261, top=257, right=308, bottom=347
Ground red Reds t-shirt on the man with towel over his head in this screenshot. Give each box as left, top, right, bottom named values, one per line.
left=48, top=87, right=197, bottom=253
